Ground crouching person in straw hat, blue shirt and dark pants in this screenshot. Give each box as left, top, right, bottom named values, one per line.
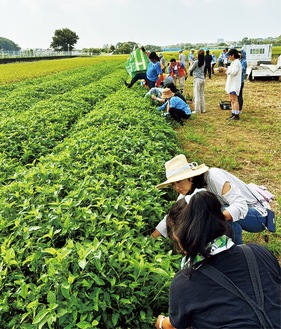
left=158, top=88, right=191, bottom=125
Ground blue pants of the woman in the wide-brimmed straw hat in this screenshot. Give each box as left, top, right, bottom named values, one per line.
left=230, top=208, right=266, bottom=244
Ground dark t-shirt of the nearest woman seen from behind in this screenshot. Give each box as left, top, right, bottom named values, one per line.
left=169, top=244, right=281, bottom=329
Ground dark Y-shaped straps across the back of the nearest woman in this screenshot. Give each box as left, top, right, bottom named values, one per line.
left=198, top=245, right=274, bottom=329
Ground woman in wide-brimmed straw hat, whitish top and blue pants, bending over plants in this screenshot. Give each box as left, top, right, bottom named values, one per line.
left=151, top=154, right=270, bottom=244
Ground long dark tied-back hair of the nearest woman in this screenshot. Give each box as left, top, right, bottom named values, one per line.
left=167, top=191, right=231, bottom=263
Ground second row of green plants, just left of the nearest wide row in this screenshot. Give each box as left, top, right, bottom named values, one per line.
left=0, top=70, right=124, bottom=182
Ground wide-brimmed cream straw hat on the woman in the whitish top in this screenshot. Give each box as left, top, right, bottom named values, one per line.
left=156, top=154, right=209, bottom=188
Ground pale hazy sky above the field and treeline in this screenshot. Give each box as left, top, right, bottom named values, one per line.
left=0, top=0, right=281, bottom=49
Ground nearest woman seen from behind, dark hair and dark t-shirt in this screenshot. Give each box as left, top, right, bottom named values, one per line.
left=155, top=191, right=281, bottom=329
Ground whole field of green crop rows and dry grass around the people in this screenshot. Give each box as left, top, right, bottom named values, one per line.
left=0, top=54, right=281, bottom=329
